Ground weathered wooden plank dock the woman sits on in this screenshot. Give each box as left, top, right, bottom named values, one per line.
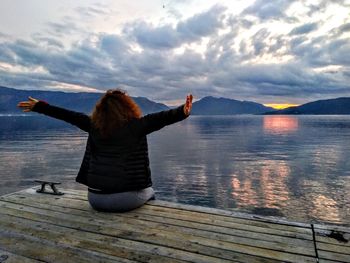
left=0, top=188, right=350, bottom=263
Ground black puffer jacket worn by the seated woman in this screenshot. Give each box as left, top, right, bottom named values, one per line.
left=32, top=101, right=187, bottom=193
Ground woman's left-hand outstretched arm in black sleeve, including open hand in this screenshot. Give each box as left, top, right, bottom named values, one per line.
left=17, top=97, right=91, bottom=132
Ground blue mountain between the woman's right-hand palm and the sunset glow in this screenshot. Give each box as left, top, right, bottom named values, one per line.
left=192, top=96, right=273, bottom=115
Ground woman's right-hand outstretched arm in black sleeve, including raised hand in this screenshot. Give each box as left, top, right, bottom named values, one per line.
left=136, top=94, right=193, bottom=135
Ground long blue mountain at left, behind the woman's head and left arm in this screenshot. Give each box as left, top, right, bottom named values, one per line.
left=0, top=86, right=169, bottom=114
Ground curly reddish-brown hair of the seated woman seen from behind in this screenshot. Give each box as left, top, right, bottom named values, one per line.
left=91, top=89, right=142, bottom=138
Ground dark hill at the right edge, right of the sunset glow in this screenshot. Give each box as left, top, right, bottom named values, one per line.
left=265, top=98, right=350, bottom=115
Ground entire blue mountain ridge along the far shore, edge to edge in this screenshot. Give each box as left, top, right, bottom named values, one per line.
left=0, top=86, right=350, bottom=115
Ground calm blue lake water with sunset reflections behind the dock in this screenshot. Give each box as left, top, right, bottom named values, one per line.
left=0, top=116, right=350, bottom=225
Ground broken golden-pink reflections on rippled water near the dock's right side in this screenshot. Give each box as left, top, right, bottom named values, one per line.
left=231, top=160, right=350, bottom=223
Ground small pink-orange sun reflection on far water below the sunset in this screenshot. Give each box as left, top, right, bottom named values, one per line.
left=263, top=115, right=299, bottom=133
